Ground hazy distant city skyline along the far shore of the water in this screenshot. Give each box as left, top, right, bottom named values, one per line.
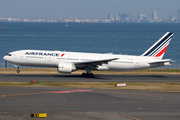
left=0, top=10, right=180, bottom=23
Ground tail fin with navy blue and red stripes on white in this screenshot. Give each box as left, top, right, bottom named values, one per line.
left=142, top=32, right=174, bottom=59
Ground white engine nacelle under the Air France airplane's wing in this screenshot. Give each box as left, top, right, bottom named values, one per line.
left=58, top=62, right=76, bottom=73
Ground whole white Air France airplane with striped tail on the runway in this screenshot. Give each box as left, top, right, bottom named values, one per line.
left=3, top=32, right=174, bottom=76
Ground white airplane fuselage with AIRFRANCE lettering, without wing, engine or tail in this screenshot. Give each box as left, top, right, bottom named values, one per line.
left=4, top=50, right=164, bottom=71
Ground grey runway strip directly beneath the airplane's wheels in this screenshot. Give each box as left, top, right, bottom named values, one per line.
left=0, top=74, right=180, bottom=82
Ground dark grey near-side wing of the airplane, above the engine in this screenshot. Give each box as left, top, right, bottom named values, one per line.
left=74, top=58, right=119, bottom=66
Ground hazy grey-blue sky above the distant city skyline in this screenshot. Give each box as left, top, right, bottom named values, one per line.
left=0, top=0, right=180, bottom=19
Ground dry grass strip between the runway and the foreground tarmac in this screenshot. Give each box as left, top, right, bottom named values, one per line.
left=0, top=82, right=180, bottom=92
